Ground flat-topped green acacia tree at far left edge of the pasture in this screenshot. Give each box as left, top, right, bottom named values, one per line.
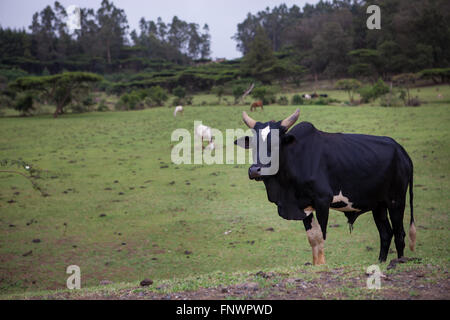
left=10, top=72, right=102, bottom=118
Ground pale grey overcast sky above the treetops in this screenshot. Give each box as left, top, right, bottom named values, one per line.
left=0, top=0, right=318, bottom=59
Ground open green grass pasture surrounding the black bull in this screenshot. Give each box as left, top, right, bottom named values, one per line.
left=0, top=87, right=450, bottom=295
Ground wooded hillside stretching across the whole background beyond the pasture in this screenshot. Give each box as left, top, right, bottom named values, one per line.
left=0, top=0, right=450, bottom=115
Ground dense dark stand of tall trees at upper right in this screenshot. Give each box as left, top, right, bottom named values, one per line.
left=234, top=0, right=450, bottom=79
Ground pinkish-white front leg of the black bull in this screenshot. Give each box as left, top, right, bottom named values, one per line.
left=303, top=207, right=325, bottom=266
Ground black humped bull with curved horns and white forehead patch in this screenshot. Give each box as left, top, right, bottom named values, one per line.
left=235, top=110, right=416, bottom=264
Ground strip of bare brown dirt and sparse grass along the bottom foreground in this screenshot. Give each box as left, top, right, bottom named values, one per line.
left=23, top=266, right=450, bottom=300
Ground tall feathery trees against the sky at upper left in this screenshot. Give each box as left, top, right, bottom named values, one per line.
left=0, top=0, right=210, bottom=74
